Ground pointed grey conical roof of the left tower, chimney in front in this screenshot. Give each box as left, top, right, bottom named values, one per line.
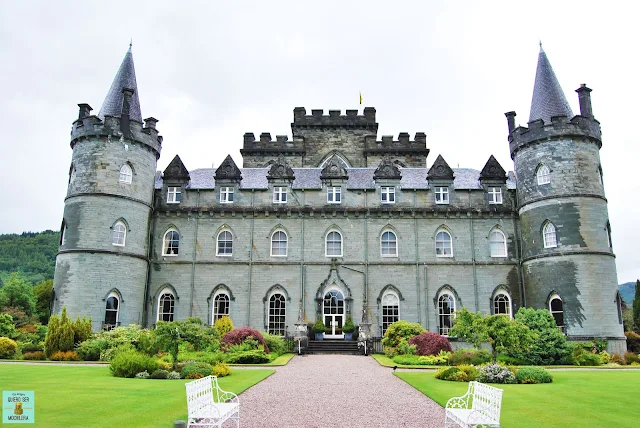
left=98, top=45, right=142, bottom=123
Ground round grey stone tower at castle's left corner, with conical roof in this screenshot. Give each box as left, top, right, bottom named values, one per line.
left=53, top=49, right=162, bottom=330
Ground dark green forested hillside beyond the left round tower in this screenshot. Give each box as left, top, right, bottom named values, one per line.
left=0, top=230, right=60, bottom=284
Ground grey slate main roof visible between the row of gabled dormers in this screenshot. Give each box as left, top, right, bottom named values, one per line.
left=155, top=168, right=516, bottom=190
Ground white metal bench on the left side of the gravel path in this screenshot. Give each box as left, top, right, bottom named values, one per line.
left=185, top=376, right=240, bottom=428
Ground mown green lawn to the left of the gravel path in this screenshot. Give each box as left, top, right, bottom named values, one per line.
left=0, top=364, right=275, bottom=428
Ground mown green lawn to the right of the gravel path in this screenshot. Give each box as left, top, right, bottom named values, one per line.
left=395, top=370, right=640, bottom=428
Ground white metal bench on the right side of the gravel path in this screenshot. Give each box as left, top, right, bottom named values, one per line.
left=444, top=382, right=502, bottom=427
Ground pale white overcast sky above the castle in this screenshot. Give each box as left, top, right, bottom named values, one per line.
left=0, top=0, right=640, bottom=283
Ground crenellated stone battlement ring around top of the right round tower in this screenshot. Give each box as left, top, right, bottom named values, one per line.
left=507, top=112, right=602, bottom=159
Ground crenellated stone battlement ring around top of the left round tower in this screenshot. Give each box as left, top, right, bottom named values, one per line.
left=71, top=104, right=162, bottom=158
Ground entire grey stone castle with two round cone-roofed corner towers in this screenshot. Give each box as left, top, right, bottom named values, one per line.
left=53, top=48, right=626, bottom=352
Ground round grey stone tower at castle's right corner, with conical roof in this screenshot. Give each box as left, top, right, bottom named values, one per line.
left=506, top=48, right=626, bottom=352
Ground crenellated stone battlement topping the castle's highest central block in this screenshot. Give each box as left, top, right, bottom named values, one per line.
left=291, top=107, right=378, bottom=129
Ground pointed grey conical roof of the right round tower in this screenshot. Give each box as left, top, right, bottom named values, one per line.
left=529, top=44, right=573, bottom=123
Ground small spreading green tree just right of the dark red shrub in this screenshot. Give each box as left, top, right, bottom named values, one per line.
left=450, top=308, right=535, bottom=362
